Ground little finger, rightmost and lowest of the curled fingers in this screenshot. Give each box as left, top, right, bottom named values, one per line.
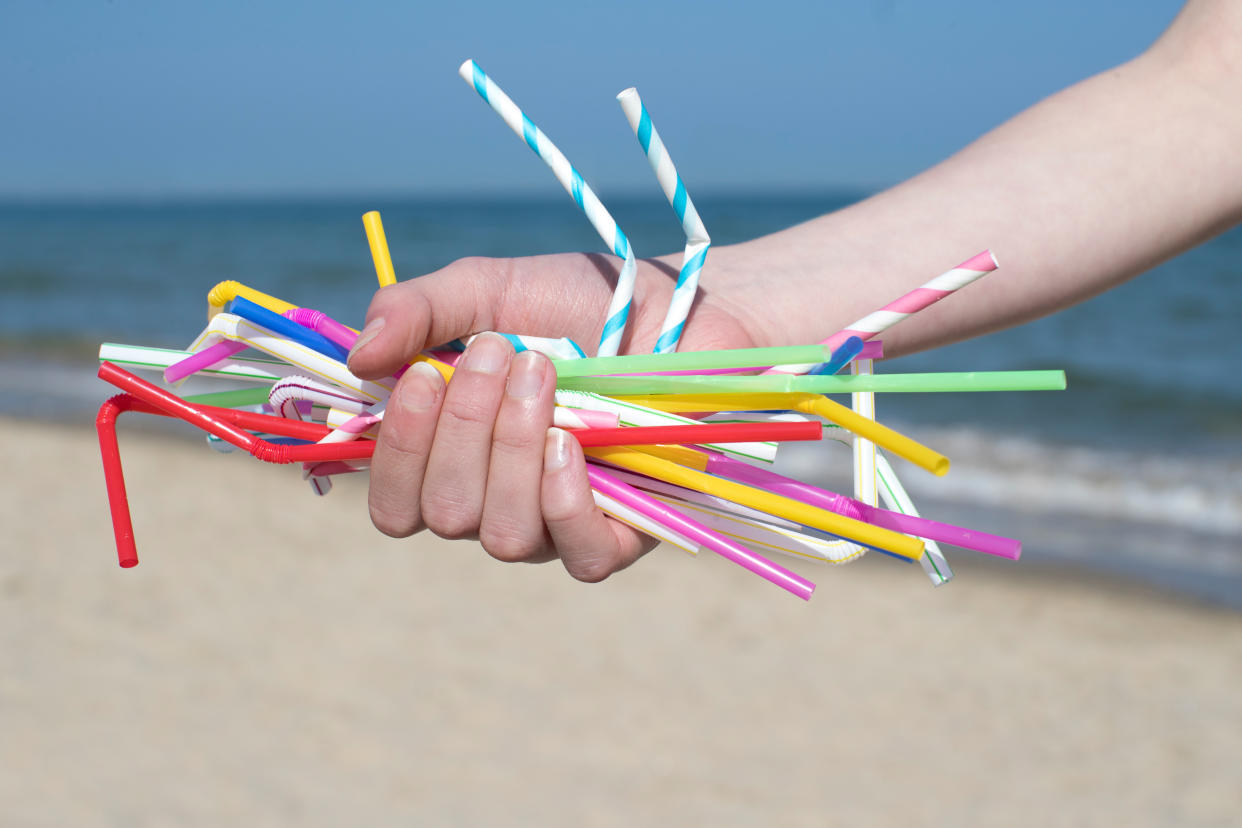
left=540, top=428, right=655, bottom=582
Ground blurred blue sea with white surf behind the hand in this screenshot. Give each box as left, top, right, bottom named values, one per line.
left=0, top=191, right=1242, bottom=610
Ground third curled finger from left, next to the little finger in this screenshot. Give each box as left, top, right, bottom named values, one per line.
left=478, top=351, right=556, bottom=562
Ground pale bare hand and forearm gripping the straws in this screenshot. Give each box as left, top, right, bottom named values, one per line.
left=349, top=0, right=1242, bottom=581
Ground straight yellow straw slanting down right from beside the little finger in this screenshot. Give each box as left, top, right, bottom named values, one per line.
left=585, top=446, right=923, bottom=560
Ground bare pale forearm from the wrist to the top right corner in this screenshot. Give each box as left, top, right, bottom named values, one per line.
left=704, top=0, right=1242, bottom=355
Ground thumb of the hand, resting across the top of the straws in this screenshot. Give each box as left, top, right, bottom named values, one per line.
left=349, top=258, right=509, bottom=380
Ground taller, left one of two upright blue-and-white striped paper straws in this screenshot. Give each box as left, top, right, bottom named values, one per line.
left=457, top=61, right=637, bottom=356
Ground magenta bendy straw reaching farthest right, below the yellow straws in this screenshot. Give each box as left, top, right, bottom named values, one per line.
left=707, top=451, right=1022, bottom=561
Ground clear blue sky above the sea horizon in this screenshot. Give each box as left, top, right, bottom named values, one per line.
left=0, top=0, right=1181, bottom=197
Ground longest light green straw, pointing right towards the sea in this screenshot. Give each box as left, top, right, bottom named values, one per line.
left=556, top=369, right=1066, bottom=396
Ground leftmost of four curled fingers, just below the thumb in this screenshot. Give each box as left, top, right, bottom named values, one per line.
left=368, top=362, right=445, bottom=538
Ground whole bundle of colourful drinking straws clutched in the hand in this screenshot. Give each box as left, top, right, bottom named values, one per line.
left=96, top=61, right=1066, bottom=600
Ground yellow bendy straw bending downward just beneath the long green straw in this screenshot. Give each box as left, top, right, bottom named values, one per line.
left=617, top=394, right=949, bottom=475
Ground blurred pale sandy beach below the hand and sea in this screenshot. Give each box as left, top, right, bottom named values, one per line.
left=0, top=417, right=1242, bottom=826
